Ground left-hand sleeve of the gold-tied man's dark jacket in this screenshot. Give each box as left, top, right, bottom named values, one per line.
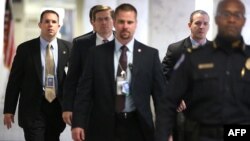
left=4, top=45, right=27, bottom=114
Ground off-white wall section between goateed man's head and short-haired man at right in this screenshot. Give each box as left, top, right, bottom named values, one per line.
left=148, top=0, right=195, bottom=59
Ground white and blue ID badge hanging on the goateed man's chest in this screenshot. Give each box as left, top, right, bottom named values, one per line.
left=116, top=76, right=129, bottom=96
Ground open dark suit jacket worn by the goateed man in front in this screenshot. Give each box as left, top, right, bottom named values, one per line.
left=72, top=40, right=165, bottom=141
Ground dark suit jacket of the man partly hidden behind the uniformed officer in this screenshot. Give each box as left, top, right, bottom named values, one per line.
left=162, top=37, right=211, bottom=80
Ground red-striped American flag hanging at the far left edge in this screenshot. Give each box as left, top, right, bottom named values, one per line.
left=3, top=0, right=16, bottom=68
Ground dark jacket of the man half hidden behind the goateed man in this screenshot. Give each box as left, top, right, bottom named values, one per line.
left=63, top=33, right=96, bottom=111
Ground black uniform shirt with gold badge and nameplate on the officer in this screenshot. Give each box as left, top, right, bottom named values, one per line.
left=167, top=37, right=250, bottom=131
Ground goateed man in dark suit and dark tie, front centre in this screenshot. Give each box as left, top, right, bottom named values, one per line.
left=72, top=4, right=167, bottom=141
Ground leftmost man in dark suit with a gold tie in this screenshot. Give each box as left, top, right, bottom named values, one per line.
left=4, top=10, right=71, bottom=141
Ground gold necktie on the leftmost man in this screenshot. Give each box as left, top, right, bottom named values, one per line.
left=45, top=44, right=56, bottom=102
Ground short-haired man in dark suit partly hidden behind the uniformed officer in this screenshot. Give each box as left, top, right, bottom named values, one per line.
left=162, top=10, right=210, bottom=80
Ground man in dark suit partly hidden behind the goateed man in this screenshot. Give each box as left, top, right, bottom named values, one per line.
left=62, top=5, right=114, bottom=125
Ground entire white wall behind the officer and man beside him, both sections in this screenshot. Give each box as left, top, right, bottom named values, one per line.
left=148, top=0, right=250, bottom=59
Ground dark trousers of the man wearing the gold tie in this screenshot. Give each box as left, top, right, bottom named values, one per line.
left=23, top=99, right=66, bottom=141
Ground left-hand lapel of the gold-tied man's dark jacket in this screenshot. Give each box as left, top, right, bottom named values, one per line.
left=31, top=38, right=43, bottom=85
